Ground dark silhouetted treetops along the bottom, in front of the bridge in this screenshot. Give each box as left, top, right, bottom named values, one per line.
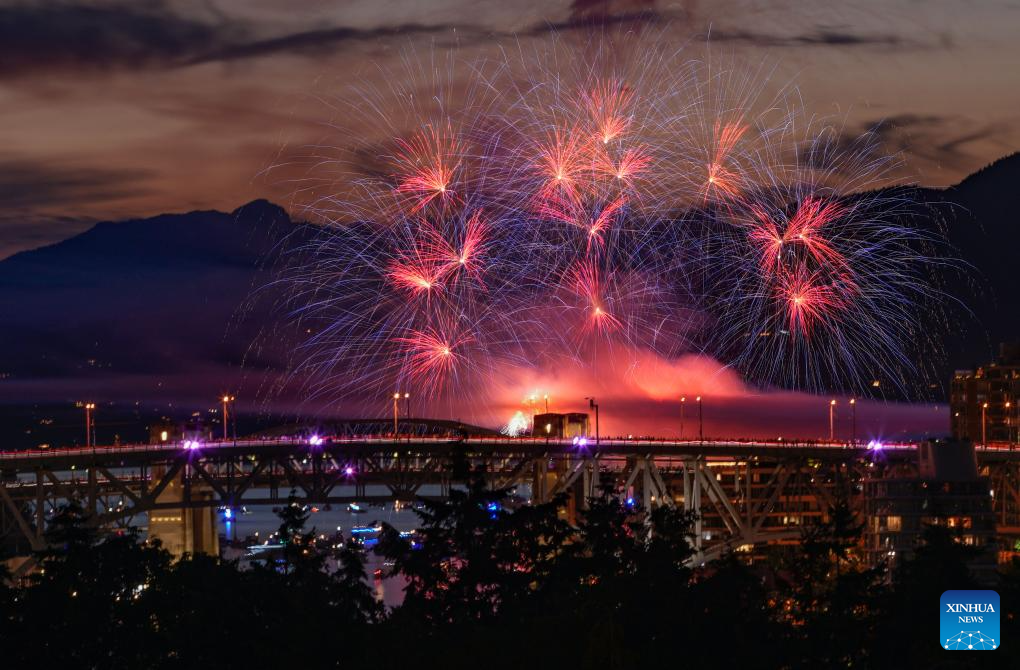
left=0, top=473, right=1020, bottom=670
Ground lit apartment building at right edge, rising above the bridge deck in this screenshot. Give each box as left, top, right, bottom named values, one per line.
left=950, top=343, right=1020, bottom=445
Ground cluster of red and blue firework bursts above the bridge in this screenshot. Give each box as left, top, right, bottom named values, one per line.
left=275, top=36, right=939, bottom=416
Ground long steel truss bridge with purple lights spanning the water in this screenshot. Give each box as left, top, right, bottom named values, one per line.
left=0, top=434, right=1020, bottom=575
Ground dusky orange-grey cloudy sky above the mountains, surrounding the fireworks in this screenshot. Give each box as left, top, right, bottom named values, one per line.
left=0, top=0, right=1020, bottom=257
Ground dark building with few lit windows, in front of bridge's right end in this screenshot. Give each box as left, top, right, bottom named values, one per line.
left=864, top=441, right=997, bottom=576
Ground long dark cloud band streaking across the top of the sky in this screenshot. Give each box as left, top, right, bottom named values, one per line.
left=0, top=0, right=938, bottom=78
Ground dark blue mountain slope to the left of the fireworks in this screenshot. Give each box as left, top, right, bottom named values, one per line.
left=0, top=201, right=300, bottom=391
